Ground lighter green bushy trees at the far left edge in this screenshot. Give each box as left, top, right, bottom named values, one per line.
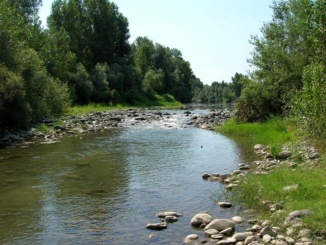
left=0, top=1, right=69, bottom=127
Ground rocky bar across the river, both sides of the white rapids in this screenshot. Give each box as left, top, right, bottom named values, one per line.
left=0, top=109, right=231, bottom=147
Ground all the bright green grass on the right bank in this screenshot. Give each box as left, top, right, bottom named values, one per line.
left=215, top=118, right=326, bottom=240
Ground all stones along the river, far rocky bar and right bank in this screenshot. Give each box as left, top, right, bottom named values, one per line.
left=0, top=108, right=322, bottom=245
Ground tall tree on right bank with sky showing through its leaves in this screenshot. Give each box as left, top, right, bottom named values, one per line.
left=249, top=0, right=314, bottom=114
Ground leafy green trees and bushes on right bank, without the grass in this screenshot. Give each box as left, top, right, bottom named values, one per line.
left=237, top=0, right=326, bottom=136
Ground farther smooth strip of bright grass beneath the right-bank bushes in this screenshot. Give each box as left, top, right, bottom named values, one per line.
left=218, top=117, right=295, bottom=146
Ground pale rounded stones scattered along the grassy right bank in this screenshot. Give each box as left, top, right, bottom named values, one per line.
left=195, top=144, right=324, bottom=245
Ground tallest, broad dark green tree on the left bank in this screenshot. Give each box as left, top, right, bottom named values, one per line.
left=48, top=0, right=135, bottom=103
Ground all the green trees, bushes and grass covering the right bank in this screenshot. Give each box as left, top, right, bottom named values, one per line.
left=220, top=0, right=326, bottom=237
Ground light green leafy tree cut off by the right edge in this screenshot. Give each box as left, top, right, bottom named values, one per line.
left=291, top=0, right=326, bottom=140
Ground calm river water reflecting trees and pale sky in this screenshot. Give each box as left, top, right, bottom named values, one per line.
left=0, top=111, right=255, bottom=244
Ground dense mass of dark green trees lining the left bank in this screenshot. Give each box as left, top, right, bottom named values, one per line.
left=0, top=0, right=203, bottom=128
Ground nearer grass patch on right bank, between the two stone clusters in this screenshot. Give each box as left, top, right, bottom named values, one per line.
left=234, top=161, right=326, bottom=234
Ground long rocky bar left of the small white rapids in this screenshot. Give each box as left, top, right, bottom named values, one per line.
left=0, top=109, right=180, bottom=147
